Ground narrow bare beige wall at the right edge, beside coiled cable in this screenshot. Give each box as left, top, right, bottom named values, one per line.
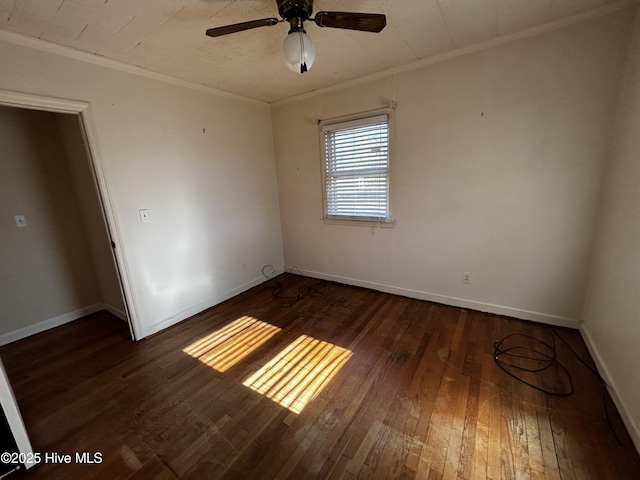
left=582, top=12, right=640, bottom=450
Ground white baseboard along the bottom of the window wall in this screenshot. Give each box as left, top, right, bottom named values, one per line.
left=287, top=268, right=580, bottom=329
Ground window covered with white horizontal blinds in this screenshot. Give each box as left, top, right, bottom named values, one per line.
left=322, top=114, right=390, bottom=222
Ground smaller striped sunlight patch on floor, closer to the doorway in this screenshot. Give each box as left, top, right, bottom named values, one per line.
left=182, top=317, right=280, bottom=372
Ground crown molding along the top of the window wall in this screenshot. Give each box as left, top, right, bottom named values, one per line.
left=269, top=0, right=640, bottom=107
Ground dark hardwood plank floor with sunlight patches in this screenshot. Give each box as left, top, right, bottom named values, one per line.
left=0, top=274, right=640, bottom=480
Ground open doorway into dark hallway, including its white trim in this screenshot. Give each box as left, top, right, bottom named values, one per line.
left=0, top=92, right=136, bottom=343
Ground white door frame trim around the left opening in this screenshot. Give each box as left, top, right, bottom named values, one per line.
left=0, top=89, right=143, bottom=340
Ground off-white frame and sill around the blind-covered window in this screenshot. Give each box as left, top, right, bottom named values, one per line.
left=316, top=108, right=395, bottom=227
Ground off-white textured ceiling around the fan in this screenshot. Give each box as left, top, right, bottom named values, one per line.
left=0, top=0, right=637, bottom=102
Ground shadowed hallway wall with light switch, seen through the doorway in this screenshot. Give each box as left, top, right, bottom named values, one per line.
left=0, top=107, right=101, bottom=335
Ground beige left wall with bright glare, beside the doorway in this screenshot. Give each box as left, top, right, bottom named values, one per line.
left=0, top=32, right=283, bottom=338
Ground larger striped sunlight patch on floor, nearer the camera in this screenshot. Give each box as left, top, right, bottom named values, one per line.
left=243, top=335, right=352, bottom=413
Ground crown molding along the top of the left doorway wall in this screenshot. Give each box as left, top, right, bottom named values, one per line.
left=0, top=28, right=269, bottom=106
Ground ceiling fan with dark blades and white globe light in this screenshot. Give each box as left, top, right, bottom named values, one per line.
left=206, top=0, right=387, bottom=73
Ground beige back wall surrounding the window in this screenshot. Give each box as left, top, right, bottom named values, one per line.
left=272, top=11, right=631, bottom=327
